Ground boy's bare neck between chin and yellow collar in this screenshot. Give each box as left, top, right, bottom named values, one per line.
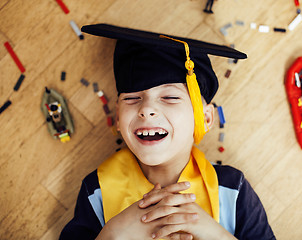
left=138, top=153, right=191, bottom=188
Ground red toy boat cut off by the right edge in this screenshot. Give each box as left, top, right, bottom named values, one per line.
left=285, top=57, right=302, bottom=149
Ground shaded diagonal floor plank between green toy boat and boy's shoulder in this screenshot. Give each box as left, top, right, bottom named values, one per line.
left=43, top=121, right=121, bottom=209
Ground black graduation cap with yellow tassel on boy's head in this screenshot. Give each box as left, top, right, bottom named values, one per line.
left=81, top=24, right=247, bottom=143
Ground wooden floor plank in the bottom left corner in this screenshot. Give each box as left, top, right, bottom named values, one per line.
left=0, top=185, right=66, bottom=240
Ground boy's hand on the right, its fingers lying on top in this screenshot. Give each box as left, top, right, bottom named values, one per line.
left=139, top=183, right=236, bottom=240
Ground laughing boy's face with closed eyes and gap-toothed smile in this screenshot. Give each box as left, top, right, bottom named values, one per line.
left=117, top=83, right=194, bottom=166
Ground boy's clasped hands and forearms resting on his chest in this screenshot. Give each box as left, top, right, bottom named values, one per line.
left=97, top=182, right=235, bottom=240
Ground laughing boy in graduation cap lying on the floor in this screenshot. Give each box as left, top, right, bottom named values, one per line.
left=60, top=24, right=275, bottom=240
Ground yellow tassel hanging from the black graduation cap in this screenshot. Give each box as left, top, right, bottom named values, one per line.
left=160, top=35, right=209, bottom=144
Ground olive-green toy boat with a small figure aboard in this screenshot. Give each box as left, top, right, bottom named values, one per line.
left=41, top=87, right=74, bottom=143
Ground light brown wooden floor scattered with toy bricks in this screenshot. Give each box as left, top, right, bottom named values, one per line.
left=0, top=0, right=302, bottom=240
